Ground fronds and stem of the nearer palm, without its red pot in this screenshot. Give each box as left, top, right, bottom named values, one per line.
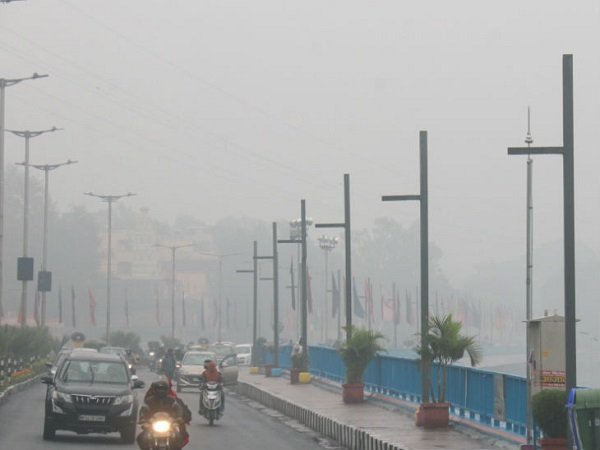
left=415, top=314, right=481, bottom=403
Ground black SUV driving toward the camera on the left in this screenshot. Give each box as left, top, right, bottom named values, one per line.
left=42, top=352, right=144, bottom=444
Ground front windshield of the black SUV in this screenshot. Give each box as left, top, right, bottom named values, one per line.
left=59, top=360, right=129, bottom=384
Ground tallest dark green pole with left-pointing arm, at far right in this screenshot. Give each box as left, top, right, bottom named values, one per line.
left=508, top=55, right=577, bottom=445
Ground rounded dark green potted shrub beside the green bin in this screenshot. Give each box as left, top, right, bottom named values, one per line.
left=531, top=389, right=568, bottom=450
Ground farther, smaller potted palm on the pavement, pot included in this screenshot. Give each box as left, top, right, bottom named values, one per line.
left=338, top=327, right=384, bottom=403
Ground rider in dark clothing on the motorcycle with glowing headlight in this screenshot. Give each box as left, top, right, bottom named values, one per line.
left=137, top=380, right=189, bottom=450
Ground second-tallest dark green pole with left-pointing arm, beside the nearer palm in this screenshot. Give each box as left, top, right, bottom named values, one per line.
left=381, top=131, right=431, bottom=403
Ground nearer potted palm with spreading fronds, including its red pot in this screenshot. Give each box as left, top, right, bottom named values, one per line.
left=415, top=314, right=481, bottom=428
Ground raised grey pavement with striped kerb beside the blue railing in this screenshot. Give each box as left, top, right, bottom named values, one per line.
left=236, top=368, right=523, bottom=450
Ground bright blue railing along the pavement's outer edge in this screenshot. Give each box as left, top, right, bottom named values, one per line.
left=265, top=346, right=527, bottom=436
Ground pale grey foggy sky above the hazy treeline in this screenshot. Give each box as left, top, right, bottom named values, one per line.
left=0, top=0, right=600, bottom=283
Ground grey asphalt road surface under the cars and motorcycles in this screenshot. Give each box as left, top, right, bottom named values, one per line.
left=0, top=373, right=334, bottom=450
